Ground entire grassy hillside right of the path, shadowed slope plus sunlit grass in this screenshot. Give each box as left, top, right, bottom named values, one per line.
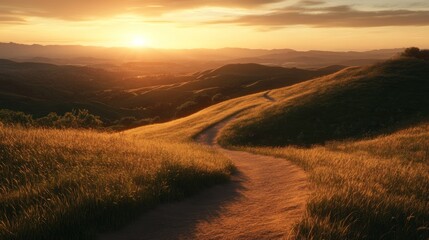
left=214, top=55, right=429, bottom=239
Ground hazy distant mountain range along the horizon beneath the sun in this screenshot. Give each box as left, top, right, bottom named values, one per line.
left=0, top=43, right=404, bottom=74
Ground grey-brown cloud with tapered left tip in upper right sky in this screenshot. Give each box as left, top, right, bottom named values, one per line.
left=212, top=1, right=429, bottom=28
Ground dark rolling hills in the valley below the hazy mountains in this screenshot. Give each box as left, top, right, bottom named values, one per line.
left=0, top=60, right=344, bottom=124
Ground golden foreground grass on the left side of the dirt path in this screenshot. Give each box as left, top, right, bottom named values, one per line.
left=0, top=126, right=232, bottom=239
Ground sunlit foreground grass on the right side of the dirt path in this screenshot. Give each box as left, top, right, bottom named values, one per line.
left=236, top=124, right=429, bottom=239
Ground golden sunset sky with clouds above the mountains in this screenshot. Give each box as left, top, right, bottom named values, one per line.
left=0, top=0, right=429, bottom=50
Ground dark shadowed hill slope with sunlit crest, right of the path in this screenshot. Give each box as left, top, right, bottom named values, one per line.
left=222, top=58, right=429, bottom=146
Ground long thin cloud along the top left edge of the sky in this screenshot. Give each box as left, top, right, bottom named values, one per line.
left=0, top=0, right=284, bottom=21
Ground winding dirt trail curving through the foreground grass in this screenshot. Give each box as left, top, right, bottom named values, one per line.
left=101, top=95, right=309, bottom=240
